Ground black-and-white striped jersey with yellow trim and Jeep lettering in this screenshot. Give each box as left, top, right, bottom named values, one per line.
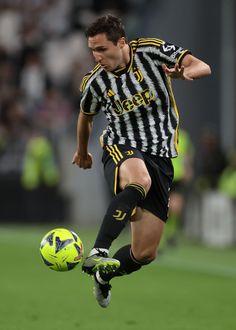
left=80, top=38, right=189, bottom=158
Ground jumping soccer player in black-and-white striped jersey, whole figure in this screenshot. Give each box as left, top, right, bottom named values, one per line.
left=72, top=15, right=211, bottom=307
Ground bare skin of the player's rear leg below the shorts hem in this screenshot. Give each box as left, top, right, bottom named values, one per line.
left=131, top=207, right=165, bottom=262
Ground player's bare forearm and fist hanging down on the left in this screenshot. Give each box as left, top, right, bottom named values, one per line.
left=72, top=111, right=93, bottom=169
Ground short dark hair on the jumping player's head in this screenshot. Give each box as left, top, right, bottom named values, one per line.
left=85, top=15, right=126, bottom=44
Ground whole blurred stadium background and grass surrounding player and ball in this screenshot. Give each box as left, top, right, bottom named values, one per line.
left=0, top=0, right=236, bottom=330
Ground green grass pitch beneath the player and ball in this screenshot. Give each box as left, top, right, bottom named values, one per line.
left=0, top=226, right=236, bottom=330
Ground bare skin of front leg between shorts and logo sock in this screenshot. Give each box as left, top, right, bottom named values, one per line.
left=119, top=158, right=151, bottom=191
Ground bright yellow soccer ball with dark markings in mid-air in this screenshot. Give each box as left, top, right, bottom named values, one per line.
left=40, top=228, right=84, bottom=272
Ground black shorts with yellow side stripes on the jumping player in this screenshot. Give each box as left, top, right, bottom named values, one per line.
left=102, top=145, right=174, bottom=222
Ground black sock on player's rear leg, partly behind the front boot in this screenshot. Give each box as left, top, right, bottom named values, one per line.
left=100, top=244, right=142, bottom=281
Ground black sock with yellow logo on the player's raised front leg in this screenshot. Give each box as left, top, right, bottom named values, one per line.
left=94, top=183, right=146, bottom=249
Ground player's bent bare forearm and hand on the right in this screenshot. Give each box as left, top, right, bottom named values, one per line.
left=162, top=54, right=211, bottom=80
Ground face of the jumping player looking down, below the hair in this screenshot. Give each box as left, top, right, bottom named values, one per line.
left=88, top=33, right=126, bottom=71
